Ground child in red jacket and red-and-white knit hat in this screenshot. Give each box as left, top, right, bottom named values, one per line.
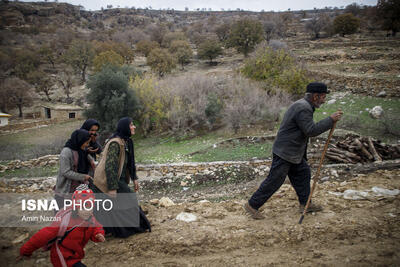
left=18, top=184, right=105, bottom=267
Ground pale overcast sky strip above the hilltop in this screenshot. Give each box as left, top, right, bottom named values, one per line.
left=24, top=0, right=377, bottom=11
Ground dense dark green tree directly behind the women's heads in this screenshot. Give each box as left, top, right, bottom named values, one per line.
left=85, top=66, right=138, bottom=133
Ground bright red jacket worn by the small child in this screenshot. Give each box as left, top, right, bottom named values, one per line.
left=20, top=216, right=104, bottom=267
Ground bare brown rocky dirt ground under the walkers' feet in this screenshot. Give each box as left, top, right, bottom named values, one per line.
left=0, top=168, right=400, bottom=266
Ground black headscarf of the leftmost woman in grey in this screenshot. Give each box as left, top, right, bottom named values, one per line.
left=65, top=129, right=90, bottom=174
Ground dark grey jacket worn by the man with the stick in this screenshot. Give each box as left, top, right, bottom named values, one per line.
left=272, top=98, right=333, bottom=164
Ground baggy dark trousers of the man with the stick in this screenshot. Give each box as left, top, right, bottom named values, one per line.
left=249, top=154, right=311, bottom=210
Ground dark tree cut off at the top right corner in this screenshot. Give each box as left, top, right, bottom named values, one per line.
left=377, top=0, right=400, bottom=36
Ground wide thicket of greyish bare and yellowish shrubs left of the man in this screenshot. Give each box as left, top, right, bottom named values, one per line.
left=131, top=74, right=289, bottom=135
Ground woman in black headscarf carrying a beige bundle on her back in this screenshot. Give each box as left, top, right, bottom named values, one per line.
left=92, top=117, right=151, bottom=237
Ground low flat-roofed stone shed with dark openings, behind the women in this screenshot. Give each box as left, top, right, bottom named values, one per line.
left=40, top=104, right=84, bottom=120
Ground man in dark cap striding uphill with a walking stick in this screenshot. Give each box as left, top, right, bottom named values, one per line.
left=244, top=82, right=343, bottom=220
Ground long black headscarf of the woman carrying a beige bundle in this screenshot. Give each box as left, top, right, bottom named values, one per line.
left=111, top=117, right=137, bottom=180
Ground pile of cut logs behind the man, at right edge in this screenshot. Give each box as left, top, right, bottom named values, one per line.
left=326, top=135, right=400, bottom=163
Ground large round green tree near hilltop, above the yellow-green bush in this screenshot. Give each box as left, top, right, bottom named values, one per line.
left=227, top=18, right=264, bottom=57
